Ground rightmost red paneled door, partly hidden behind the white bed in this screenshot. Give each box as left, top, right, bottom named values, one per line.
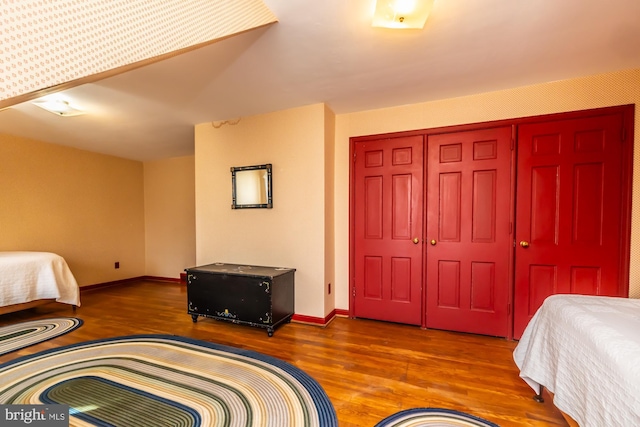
left=514, top=114, right=622, bottom=338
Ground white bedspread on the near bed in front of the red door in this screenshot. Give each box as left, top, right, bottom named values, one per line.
left=513, top=295, right=640, bottom=427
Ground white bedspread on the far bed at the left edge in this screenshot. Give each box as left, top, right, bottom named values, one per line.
left=0, top=252, right=80, bottom=307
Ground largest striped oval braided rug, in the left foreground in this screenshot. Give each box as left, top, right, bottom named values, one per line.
left=0, top=335, right=337, bottom=427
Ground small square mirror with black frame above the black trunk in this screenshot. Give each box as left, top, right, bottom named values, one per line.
left=231, top=164, right=273, bottom=209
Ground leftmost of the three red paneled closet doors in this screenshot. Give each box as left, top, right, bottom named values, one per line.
left=354, top=136, right=424, bottom=325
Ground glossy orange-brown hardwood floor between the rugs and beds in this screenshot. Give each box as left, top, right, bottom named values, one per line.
left=0, top=281, right=567, bottom=427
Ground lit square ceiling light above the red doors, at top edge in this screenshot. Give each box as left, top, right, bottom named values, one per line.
left=371, top=0, right=434, bottom=28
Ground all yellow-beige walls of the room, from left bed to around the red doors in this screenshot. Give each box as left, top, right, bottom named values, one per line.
left=7, top=66, right=640, bottom=317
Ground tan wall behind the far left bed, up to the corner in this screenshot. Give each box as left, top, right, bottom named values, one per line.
left=0, top=135, right=145, bottom=286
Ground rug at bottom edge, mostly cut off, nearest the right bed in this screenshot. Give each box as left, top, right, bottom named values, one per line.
left=375, top=408, right=499, bottom=427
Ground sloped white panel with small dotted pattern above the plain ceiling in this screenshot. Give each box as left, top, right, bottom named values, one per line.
left=0, top=0, right=277, bottom=101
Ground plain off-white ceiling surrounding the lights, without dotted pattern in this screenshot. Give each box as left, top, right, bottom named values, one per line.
left=0, top=0, right=640, bottom=161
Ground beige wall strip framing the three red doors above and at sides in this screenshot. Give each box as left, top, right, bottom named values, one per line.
left=335, top=69, right=640, bottom=309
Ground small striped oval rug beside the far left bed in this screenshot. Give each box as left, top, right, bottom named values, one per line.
left=0, top=317, right=82, bottom=355
